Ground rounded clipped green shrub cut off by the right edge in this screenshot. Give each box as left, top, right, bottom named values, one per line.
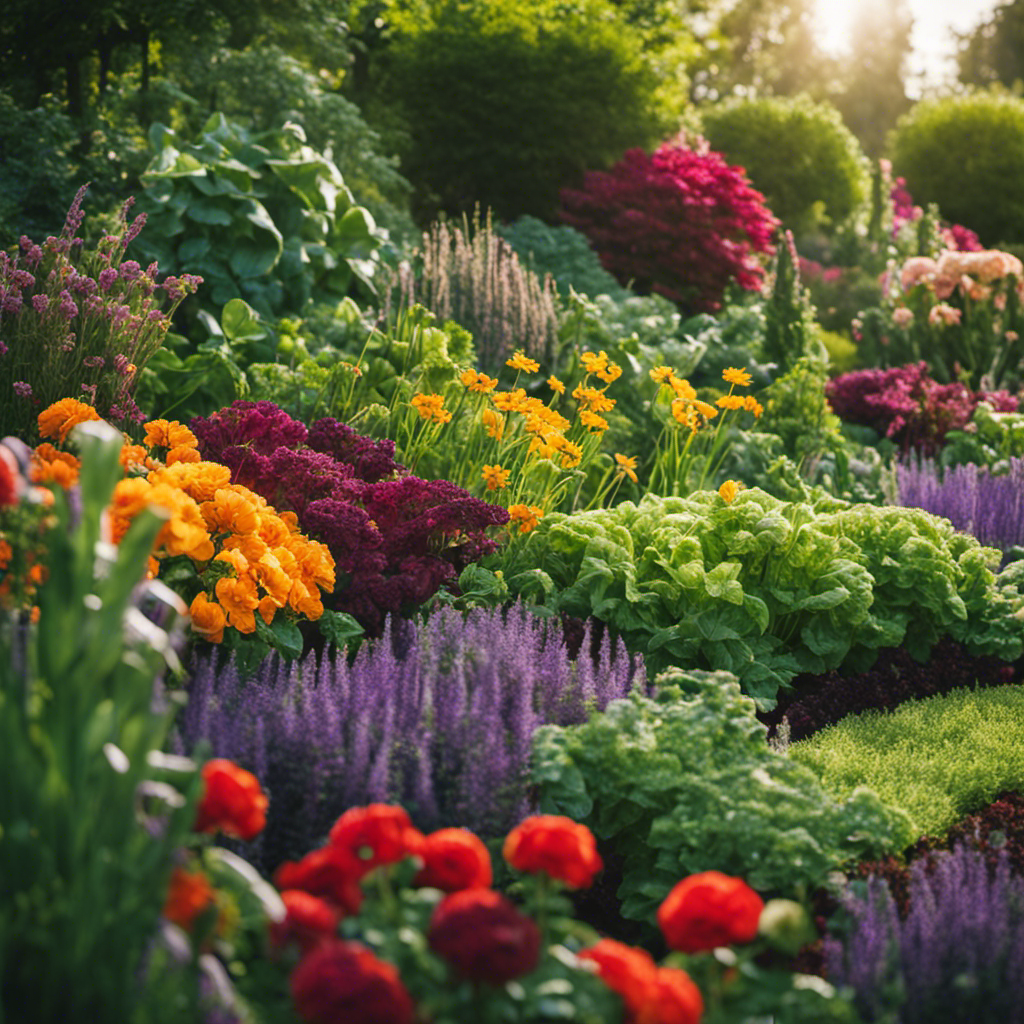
left=892, top=92, right=1024, bottom=246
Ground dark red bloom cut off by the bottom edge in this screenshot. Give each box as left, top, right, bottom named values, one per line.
left=292, top=939, right=415, bottom=1024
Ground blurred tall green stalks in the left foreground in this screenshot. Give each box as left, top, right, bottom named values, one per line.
left=0, top=424, right=201, bottom=1024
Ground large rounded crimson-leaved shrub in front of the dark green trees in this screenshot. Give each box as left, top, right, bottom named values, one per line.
left=560, top=136, right=778, bottom=312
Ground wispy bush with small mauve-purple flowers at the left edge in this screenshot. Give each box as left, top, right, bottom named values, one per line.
left=0, top=185, right=203, bottom=437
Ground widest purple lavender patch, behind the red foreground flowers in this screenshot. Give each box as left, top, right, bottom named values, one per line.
left=180, top=605, right=645, bottom=871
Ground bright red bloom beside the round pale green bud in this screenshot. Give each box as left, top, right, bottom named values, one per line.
left=657, top=871, right=764, bottom=953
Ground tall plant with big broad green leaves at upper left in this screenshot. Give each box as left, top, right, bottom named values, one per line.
left=132, top=115, right=381, bottom=318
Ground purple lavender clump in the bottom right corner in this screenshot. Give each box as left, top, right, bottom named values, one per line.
left=825, top=846, right=1024, bottom=1024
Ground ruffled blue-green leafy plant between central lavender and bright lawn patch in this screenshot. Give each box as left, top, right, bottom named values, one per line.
left=534, top=670, right=913, bottom=922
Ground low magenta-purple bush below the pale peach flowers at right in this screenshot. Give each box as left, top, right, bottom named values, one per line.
left=825, top=361, right=1017, bottom=455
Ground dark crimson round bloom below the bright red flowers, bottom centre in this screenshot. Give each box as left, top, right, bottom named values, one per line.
left=427, top=889, right=541, bottom=985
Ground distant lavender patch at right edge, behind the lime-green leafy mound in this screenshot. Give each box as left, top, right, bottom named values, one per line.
left=896, top=459, right=1024, bottom=551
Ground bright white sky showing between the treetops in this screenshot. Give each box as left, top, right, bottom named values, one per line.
left=816, top=0, right=1001, bottom=94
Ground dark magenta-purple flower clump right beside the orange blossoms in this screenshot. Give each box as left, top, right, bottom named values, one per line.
left=189, top=401, right=509, bottom=636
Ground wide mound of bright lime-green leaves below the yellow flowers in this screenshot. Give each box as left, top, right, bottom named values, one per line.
left=503, top=488, right=1024, bottom=709
